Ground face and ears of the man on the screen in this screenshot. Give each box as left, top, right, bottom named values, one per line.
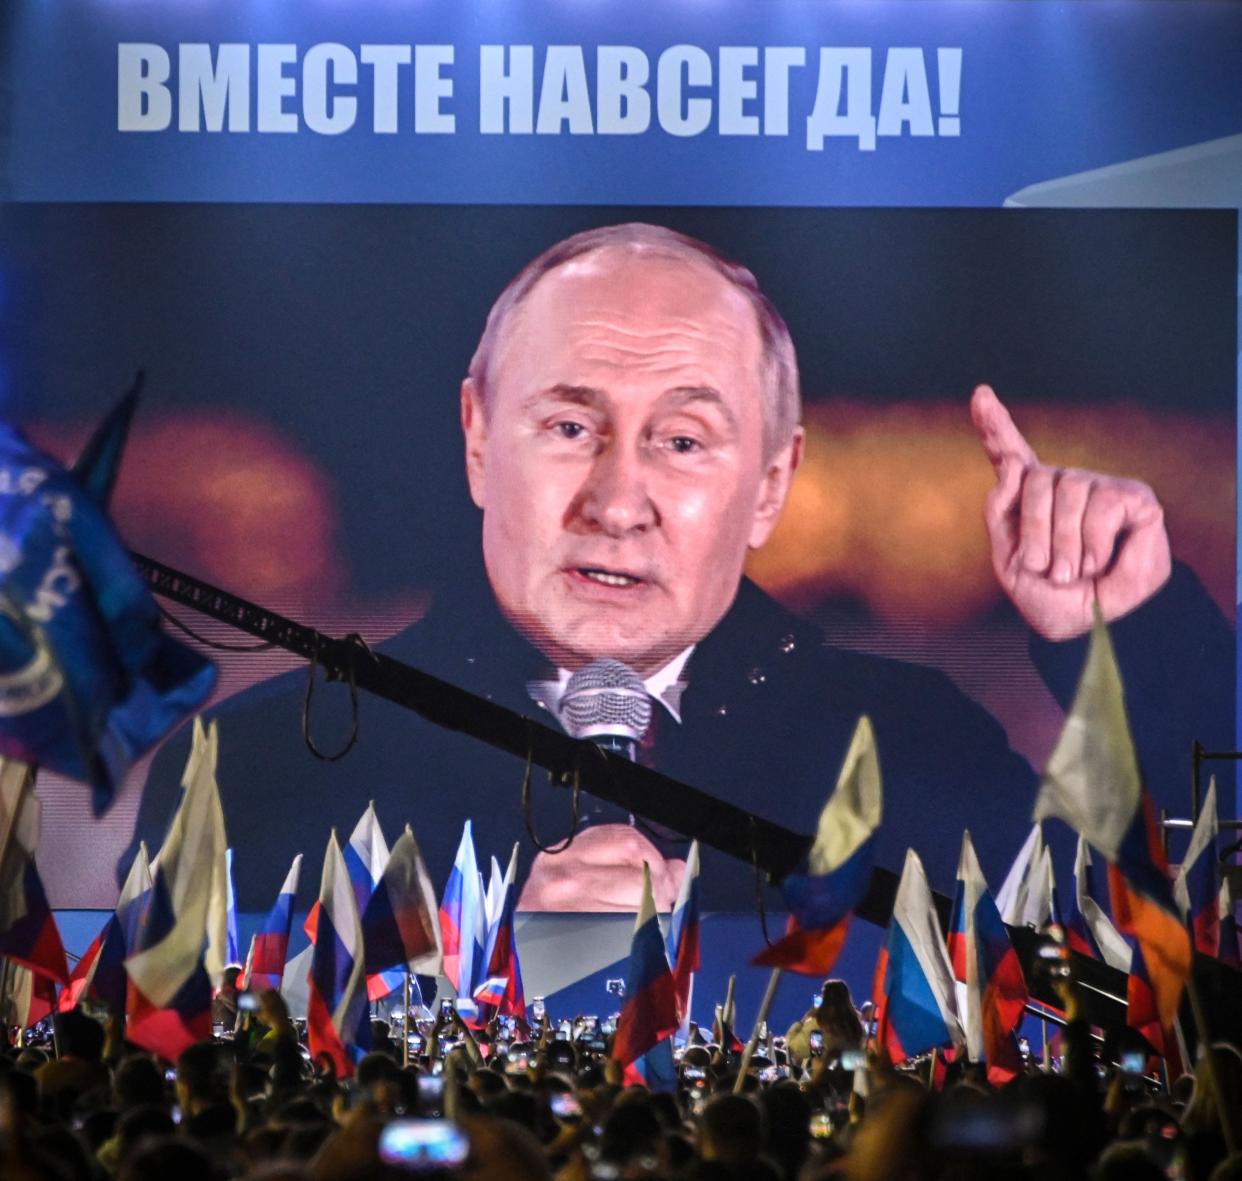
left=462, top=250, right=796, bottom=676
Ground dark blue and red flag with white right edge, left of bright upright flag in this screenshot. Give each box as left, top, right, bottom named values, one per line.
left=363, top=825, right=443, bottom=980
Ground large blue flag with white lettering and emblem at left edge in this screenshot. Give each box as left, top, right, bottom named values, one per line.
left=0, top=389, right=215, bottom=815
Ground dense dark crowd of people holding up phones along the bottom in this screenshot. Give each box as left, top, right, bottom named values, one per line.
left=0, top=981, right=1242, bottom=1181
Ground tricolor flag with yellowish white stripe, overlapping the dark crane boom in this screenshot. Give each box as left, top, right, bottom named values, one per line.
left=753, top=717, right=882, bottom=976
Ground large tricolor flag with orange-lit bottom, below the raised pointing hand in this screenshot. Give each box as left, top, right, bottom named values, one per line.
left=1033, top=607, right=1191, bottom=1054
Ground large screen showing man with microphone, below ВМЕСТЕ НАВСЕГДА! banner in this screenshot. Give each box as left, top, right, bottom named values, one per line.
left=0, top=204, right=1237, bottom=910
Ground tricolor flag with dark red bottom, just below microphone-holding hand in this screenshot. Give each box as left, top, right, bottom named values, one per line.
left=612, top=862, right=678, bottom=1084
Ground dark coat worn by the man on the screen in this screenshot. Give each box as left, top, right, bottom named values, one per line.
left=124, top=568, right=1233, bottom=909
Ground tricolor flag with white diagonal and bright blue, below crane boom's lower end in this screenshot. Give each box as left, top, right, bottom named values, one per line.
left=873, top=849, right=961, bottom=1062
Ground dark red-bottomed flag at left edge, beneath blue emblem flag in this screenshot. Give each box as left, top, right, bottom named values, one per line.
left=0, top=759, right=70, bottom=984
